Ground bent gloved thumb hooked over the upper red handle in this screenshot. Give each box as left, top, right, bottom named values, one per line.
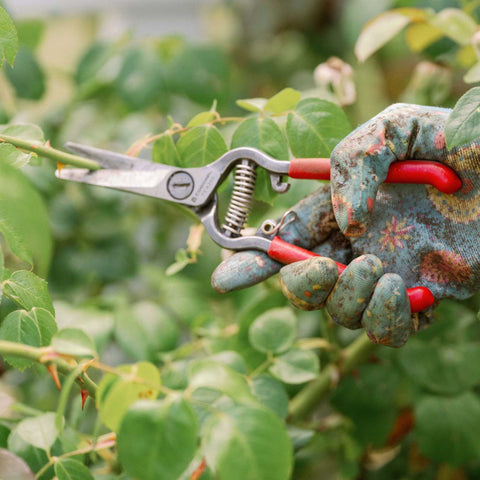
left=331, top=104, right=448, bottom=237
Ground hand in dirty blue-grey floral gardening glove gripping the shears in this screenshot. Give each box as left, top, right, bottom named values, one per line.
left=212, top=104, right=480, bottom=347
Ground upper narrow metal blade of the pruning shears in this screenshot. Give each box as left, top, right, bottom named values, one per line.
left=65, top=142, right=162, bottom=170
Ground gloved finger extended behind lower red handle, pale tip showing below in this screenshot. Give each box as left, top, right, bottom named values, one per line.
left=212, top=185, right=349, bottom=293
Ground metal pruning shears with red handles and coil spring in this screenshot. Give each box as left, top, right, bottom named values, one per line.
left=56, top=143, right=462, bottom=313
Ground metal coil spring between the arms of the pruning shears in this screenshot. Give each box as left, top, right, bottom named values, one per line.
left=222, top=160, right=257, bottom=237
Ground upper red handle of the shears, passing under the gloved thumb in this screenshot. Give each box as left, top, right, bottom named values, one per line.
left=288, top=158, right=462, bottom=194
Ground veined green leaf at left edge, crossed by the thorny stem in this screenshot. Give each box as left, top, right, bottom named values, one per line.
left=0, top=308, right=57, bottom=370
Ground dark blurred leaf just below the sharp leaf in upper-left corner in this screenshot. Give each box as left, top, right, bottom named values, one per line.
left=5, top=47, right=45, bottom=100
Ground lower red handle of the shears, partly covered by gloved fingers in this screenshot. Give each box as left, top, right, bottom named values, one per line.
left=267, top=237, right=435, bottom=313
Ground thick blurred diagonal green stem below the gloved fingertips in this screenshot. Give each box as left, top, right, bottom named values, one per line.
left=289, top=334, right=377, bottom=420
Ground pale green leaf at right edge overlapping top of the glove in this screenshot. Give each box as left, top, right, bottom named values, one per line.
left=445, top=87, right=480, bottom=148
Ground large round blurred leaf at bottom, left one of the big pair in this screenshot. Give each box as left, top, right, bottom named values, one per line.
left=117, top=398, right=199, bottom=480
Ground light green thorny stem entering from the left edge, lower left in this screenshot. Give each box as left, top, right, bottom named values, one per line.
left=0, top=340, right=97, bottom=398
